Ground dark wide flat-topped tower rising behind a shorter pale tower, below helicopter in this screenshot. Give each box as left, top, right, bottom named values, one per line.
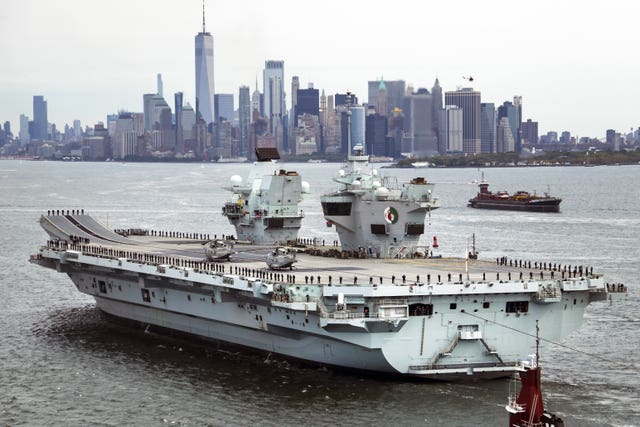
left=444, top=88, right=481, bottom=154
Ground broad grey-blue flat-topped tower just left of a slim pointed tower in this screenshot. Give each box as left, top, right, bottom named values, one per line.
left=403, top=88, right=438, bottom=157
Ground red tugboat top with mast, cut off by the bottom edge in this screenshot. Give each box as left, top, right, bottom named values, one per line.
left=505, top=325, right=564, bottom=427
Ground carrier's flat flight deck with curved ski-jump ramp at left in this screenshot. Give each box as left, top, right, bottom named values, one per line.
left=36, top=211, right=632, bottom=286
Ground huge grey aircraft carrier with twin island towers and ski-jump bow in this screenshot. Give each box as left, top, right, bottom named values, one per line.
left=30, top=113, right=626, bottom=380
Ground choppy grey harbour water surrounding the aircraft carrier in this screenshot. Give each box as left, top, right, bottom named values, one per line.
left=0, top=161, right=640, bottom=426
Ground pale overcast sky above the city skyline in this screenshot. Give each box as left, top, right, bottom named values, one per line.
left=0, top=0, right=640, bottom=137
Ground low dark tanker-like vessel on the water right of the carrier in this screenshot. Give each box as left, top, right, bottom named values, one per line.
left=468, top=174, right=562, bottom=212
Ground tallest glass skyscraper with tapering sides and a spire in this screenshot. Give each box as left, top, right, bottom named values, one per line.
left=195, top=3, right=216, bottom=125
